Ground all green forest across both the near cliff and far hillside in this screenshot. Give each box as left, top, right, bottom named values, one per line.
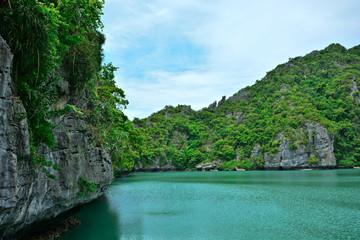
left=0, top=0, right=360, bottom=178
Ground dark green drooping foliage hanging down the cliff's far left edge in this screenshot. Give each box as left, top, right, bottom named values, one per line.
left=0, top=0, right=61, bottom=147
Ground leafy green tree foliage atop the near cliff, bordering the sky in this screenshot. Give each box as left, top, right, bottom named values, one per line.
left=57, top=0, right=105, bottom=91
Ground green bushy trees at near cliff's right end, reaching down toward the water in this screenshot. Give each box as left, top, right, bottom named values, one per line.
left=87, top=63, right=134, bottom=176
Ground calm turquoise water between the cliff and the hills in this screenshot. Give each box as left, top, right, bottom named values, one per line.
left=61, top=169, right=360, bottom=240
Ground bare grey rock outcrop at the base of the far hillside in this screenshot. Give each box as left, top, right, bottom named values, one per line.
left=251, top=123, right=336, bottom=169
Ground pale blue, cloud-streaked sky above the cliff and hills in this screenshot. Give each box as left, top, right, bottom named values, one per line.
left=102, top=0, right=360, bottom=119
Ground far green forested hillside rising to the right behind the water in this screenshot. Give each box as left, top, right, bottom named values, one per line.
left=129, top=44, right=360, bottom=170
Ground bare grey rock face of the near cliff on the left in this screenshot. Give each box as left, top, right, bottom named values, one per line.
left=0, top=37, right=113, bottom=239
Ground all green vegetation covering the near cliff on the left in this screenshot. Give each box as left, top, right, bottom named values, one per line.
left=0, top=0, right=131, bottom=177
